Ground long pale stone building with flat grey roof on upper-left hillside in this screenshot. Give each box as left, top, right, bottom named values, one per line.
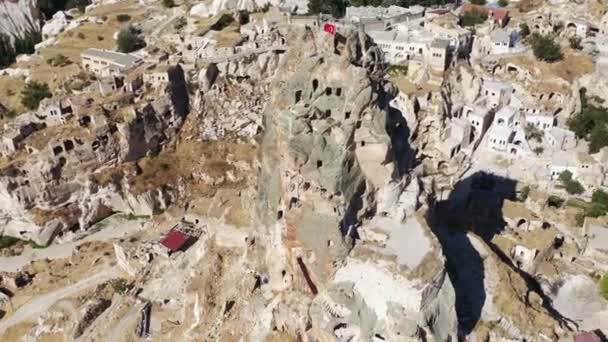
left=81, top=49, right=140, bottom=77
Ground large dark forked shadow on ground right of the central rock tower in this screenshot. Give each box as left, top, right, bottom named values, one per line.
left=427, top=172, right=572, bottom=336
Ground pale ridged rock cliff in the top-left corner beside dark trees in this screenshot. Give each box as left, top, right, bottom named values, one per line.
left=0, top=0, right=41, bottom=37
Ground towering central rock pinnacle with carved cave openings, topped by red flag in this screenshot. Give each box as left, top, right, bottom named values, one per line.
left=258, top=31, right=457, bottom=340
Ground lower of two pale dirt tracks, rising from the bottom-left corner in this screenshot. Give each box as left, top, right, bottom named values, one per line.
left=0, top=267, right=120, bottom=334
